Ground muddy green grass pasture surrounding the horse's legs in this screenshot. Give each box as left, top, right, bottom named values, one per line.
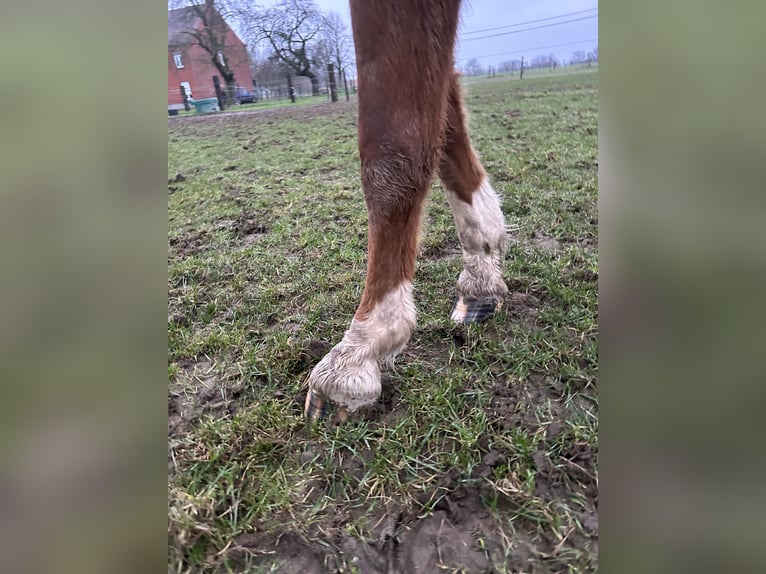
left=168, top=73, right=598, bottom=574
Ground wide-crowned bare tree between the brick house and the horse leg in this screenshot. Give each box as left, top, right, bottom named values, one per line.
left=243, top=0, right=324, bottom=95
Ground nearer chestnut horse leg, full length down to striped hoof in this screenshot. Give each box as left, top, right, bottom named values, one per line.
left=305, top=0, right=459, bottom=424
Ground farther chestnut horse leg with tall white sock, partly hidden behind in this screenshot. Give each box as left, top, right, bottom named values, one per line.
left=439, top=71, right=508, bottom=323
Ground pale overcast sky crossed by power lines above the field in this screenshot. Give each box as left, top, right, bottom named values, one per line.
left=292, top=0, right=598, bottom=66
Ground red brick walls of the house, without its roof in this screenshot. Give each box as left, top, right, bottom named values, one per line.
left=168, top=30, right=253, bottom=106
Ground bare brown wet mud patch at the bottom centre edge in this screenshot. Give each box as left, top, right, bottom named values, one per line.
left=226, top=489, right=505, bottom=574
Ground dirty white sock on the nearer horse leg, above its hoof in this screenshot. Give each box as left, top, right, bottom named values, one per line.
left=309, top=281, right=416, bottom=412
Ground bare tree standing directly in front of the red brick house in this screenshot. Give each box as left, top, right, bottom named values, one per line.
left=168, top=0, right=247, bottom=102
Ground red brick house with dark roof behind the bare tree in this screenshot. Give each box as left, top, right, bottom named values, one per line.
left=168, top=3, right=253, bottom=110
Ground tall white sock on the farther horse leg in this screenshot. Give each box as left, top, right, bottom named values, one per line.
left=446, top=178, right=508, bottom=310
